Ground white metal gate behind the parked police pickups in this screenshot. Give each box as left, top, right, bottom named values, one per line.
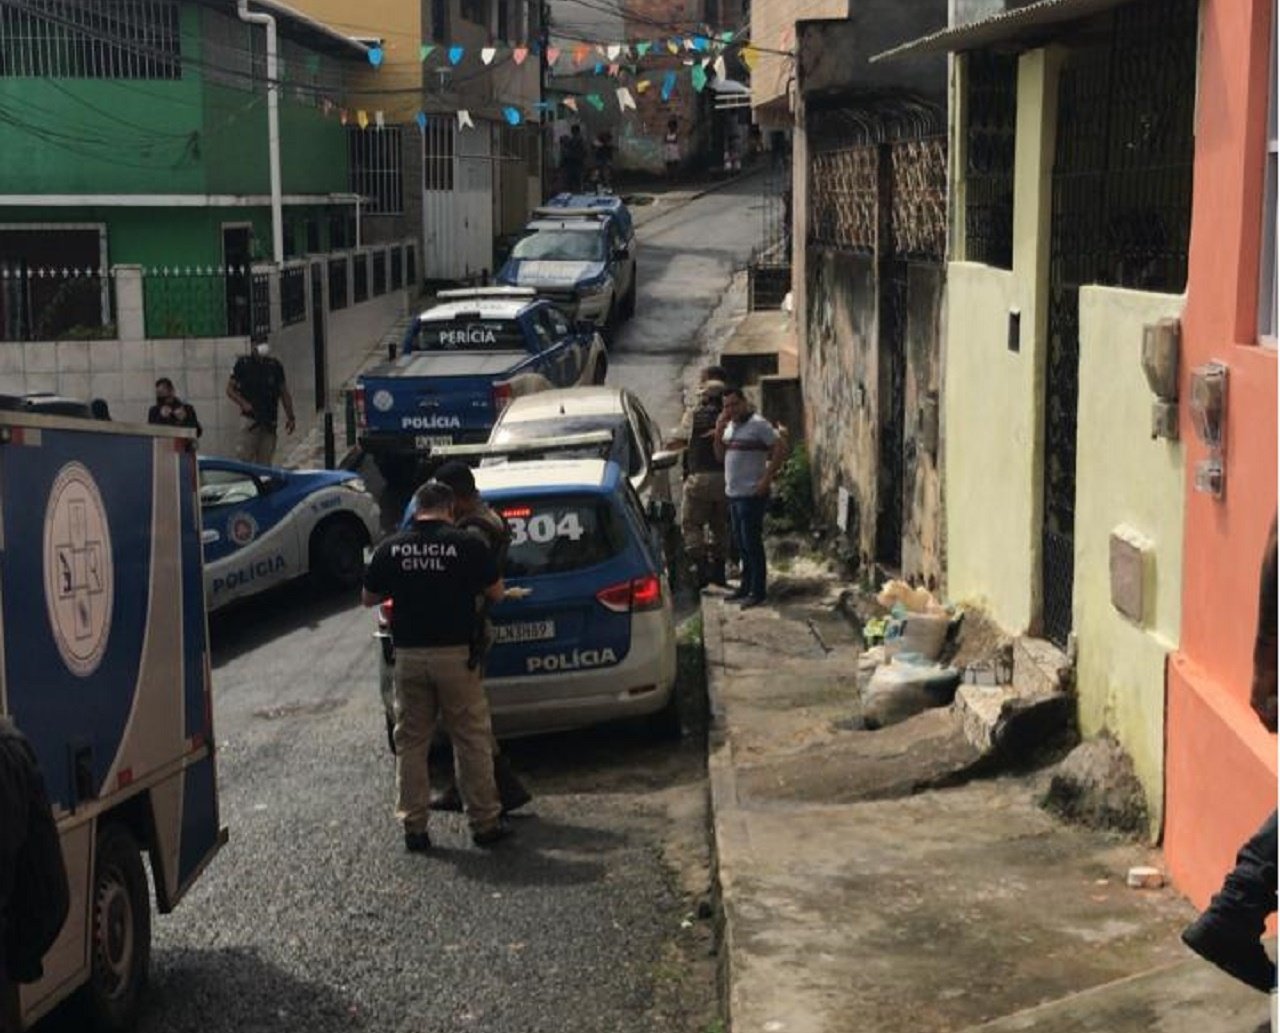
left=422, top=115, right=494, bottom=280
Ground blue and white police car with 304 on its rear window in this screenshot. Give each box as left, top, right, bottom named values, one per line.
left=379, top=458, right=680, bottom=736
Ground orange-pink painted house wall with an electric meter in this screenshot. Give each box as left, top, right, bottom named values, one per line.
left=1165, top=0, right=1276, bottom=906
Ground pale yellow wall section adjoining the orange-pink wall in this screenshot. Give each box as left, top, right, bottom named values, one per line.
left=1074, top=287, right=1184, bottom=837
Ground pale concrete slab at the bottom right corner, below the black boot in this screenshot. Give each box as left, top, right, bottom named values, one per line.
left=965, top=957, right=1271, bottom=1033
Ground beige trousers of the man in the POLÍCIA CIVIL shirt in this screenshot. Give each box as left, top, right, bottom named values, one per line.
left=393, top=645, right=502, bottom=832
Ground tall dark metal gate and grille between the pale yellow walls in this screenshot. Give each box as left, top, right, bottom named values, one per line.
left=1041, top=0, right=1198, bottom=646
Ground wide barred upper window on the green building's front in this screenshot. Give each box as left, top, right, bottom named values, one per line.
left=0, top=0, right=182, bottom=79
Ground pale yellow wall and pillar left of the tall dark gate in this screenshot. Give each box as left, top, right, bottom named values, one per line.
left=943, top=50, right=1057, bottom=634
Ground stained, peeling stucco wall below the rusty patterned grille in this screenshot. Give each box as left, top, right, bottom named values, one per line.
left=800, top=248, right=878, bottom=558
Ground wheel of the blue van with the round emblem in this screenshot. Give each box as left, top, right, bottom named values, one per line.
left=83, top=824, right=151, bottom=1033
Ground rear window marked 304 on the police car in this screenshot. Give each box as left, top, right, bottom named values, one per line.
left=494, top=497, right=626, bottom=577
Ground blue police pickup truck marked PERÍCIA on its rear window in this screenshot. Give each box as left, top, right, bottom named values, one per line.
left=355, top=287, right=608, bottom=481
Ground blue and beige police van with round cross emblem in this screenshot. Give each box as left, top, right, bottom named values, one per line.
left=0, top=404, right=225, bottom=1030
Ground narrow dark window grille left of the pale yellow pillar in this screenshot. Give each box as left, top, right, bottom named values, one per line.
left=964, top=51, right=1018, bottom=269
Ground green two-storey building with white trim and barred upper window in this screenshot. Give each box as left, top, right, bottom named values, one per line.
left=0, top=0, right=369, bottom=339
